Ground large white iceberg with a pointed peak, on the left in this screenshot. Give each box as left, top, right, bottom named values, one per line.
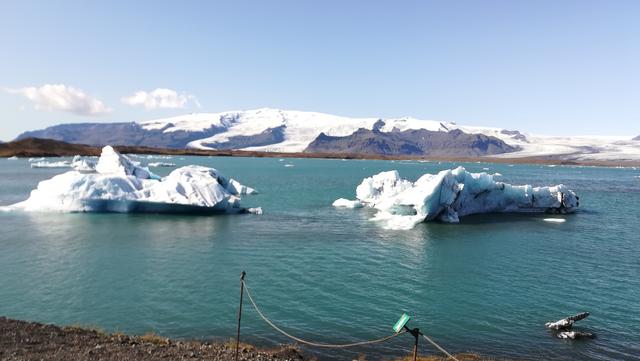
left=7, top=146, right=261, bottom=213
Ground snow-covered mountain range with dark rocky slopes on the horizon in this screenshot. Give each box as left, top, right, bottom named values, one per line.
left=13, top=108, right=640, bottom=160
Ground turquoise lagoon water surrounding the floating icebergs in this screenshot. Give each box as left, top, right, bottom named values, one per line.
left=0, top=157, right=640, bottom=360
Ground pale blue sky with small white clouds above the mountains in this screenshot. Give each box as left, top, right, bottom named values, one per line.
left=0, top=0, right=640, bottom=141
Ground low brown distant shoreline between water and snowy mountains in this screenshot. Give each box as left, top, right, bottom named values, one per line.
left=0, top=138, right=640, bottom=167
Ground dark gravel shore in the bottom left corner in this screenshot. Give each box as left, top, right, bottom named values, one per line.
left=0, top=317, right=304, bottom=361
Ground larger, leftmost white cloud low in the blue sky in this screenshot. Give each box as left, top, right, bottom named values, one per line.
left=5, top=84, right=111, bottom=116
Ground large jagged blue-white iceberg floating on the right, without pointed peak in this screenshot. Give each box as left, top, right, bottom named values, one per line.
left=334, top=167, right=578, bottom=229
